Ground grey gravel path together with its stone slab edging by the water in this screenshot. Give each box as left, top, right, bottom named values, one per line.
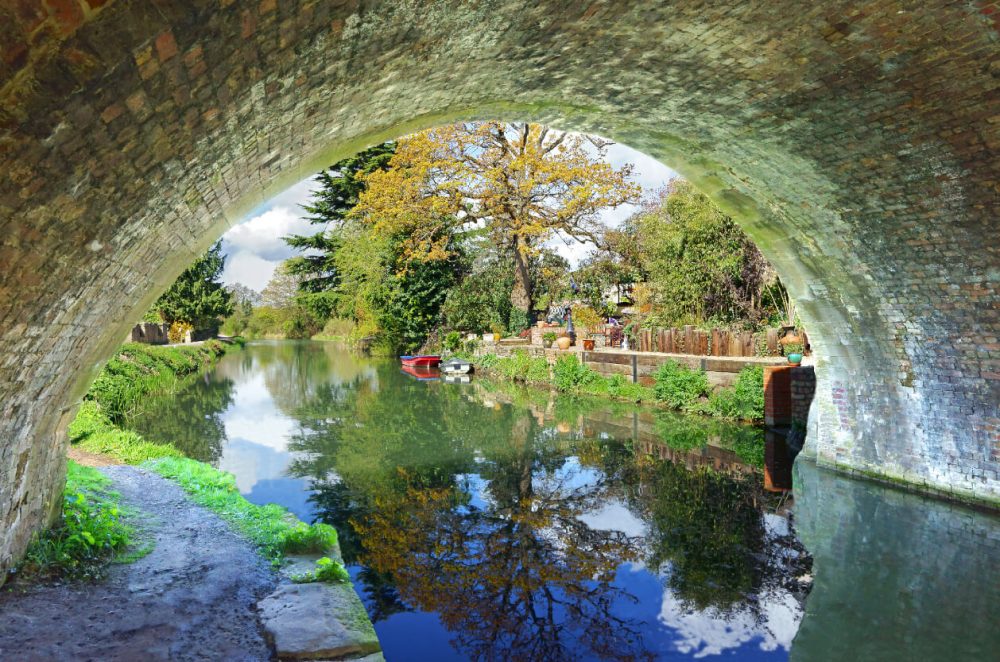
left=0, top=466, right=381, bottom=661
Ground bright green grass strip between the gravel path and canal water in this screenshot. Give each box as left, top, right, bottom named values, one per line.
left=143, top=457, right=337, bottom=562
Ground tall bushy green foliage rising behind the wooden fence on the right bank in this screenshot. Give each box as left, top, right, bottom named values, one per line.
left=633, top=181, right=775, bottom=326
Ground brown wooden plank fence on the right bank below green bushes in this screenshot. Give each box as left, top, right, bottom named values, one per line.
left=634, top=326, right=809, bottom=357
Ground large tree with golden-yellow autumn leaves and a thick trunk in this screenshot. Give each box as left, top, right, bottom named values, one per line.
left=352, top=122, right=640, bottom=320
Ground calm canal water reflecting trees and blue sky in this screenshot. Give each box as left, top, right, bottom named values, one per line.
left=131, top=342, right=1000, bottom=661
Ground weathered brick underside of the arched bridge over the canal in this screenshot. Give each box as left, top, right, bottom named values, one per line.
left=0, top=0, right=1000, bottom=571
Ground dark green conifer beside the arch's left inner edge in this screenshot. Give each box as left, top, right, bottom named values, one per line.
left=153, top=241, right=233, bottom=331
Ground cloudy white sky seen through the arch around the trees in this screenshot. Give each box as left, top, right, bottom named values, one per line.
left=222, top=137, right=677, bottom=291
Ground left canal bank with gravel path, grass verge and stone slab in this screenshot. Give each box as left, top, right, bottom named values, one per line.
left=0, top=341, right=381, bottom=660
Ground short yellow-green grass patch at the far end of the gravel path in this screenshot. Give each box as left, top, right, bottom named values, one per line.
left=69, top=400, right=182, bottom=464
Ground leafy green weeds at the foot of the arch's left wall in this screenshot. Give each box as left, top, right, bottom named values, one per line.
left=18, top=460, right=134, bottom=581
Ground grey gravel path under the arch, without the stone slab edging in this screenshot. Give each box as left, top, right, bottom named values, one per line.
left=0, top=466, right=277, bottom=662
